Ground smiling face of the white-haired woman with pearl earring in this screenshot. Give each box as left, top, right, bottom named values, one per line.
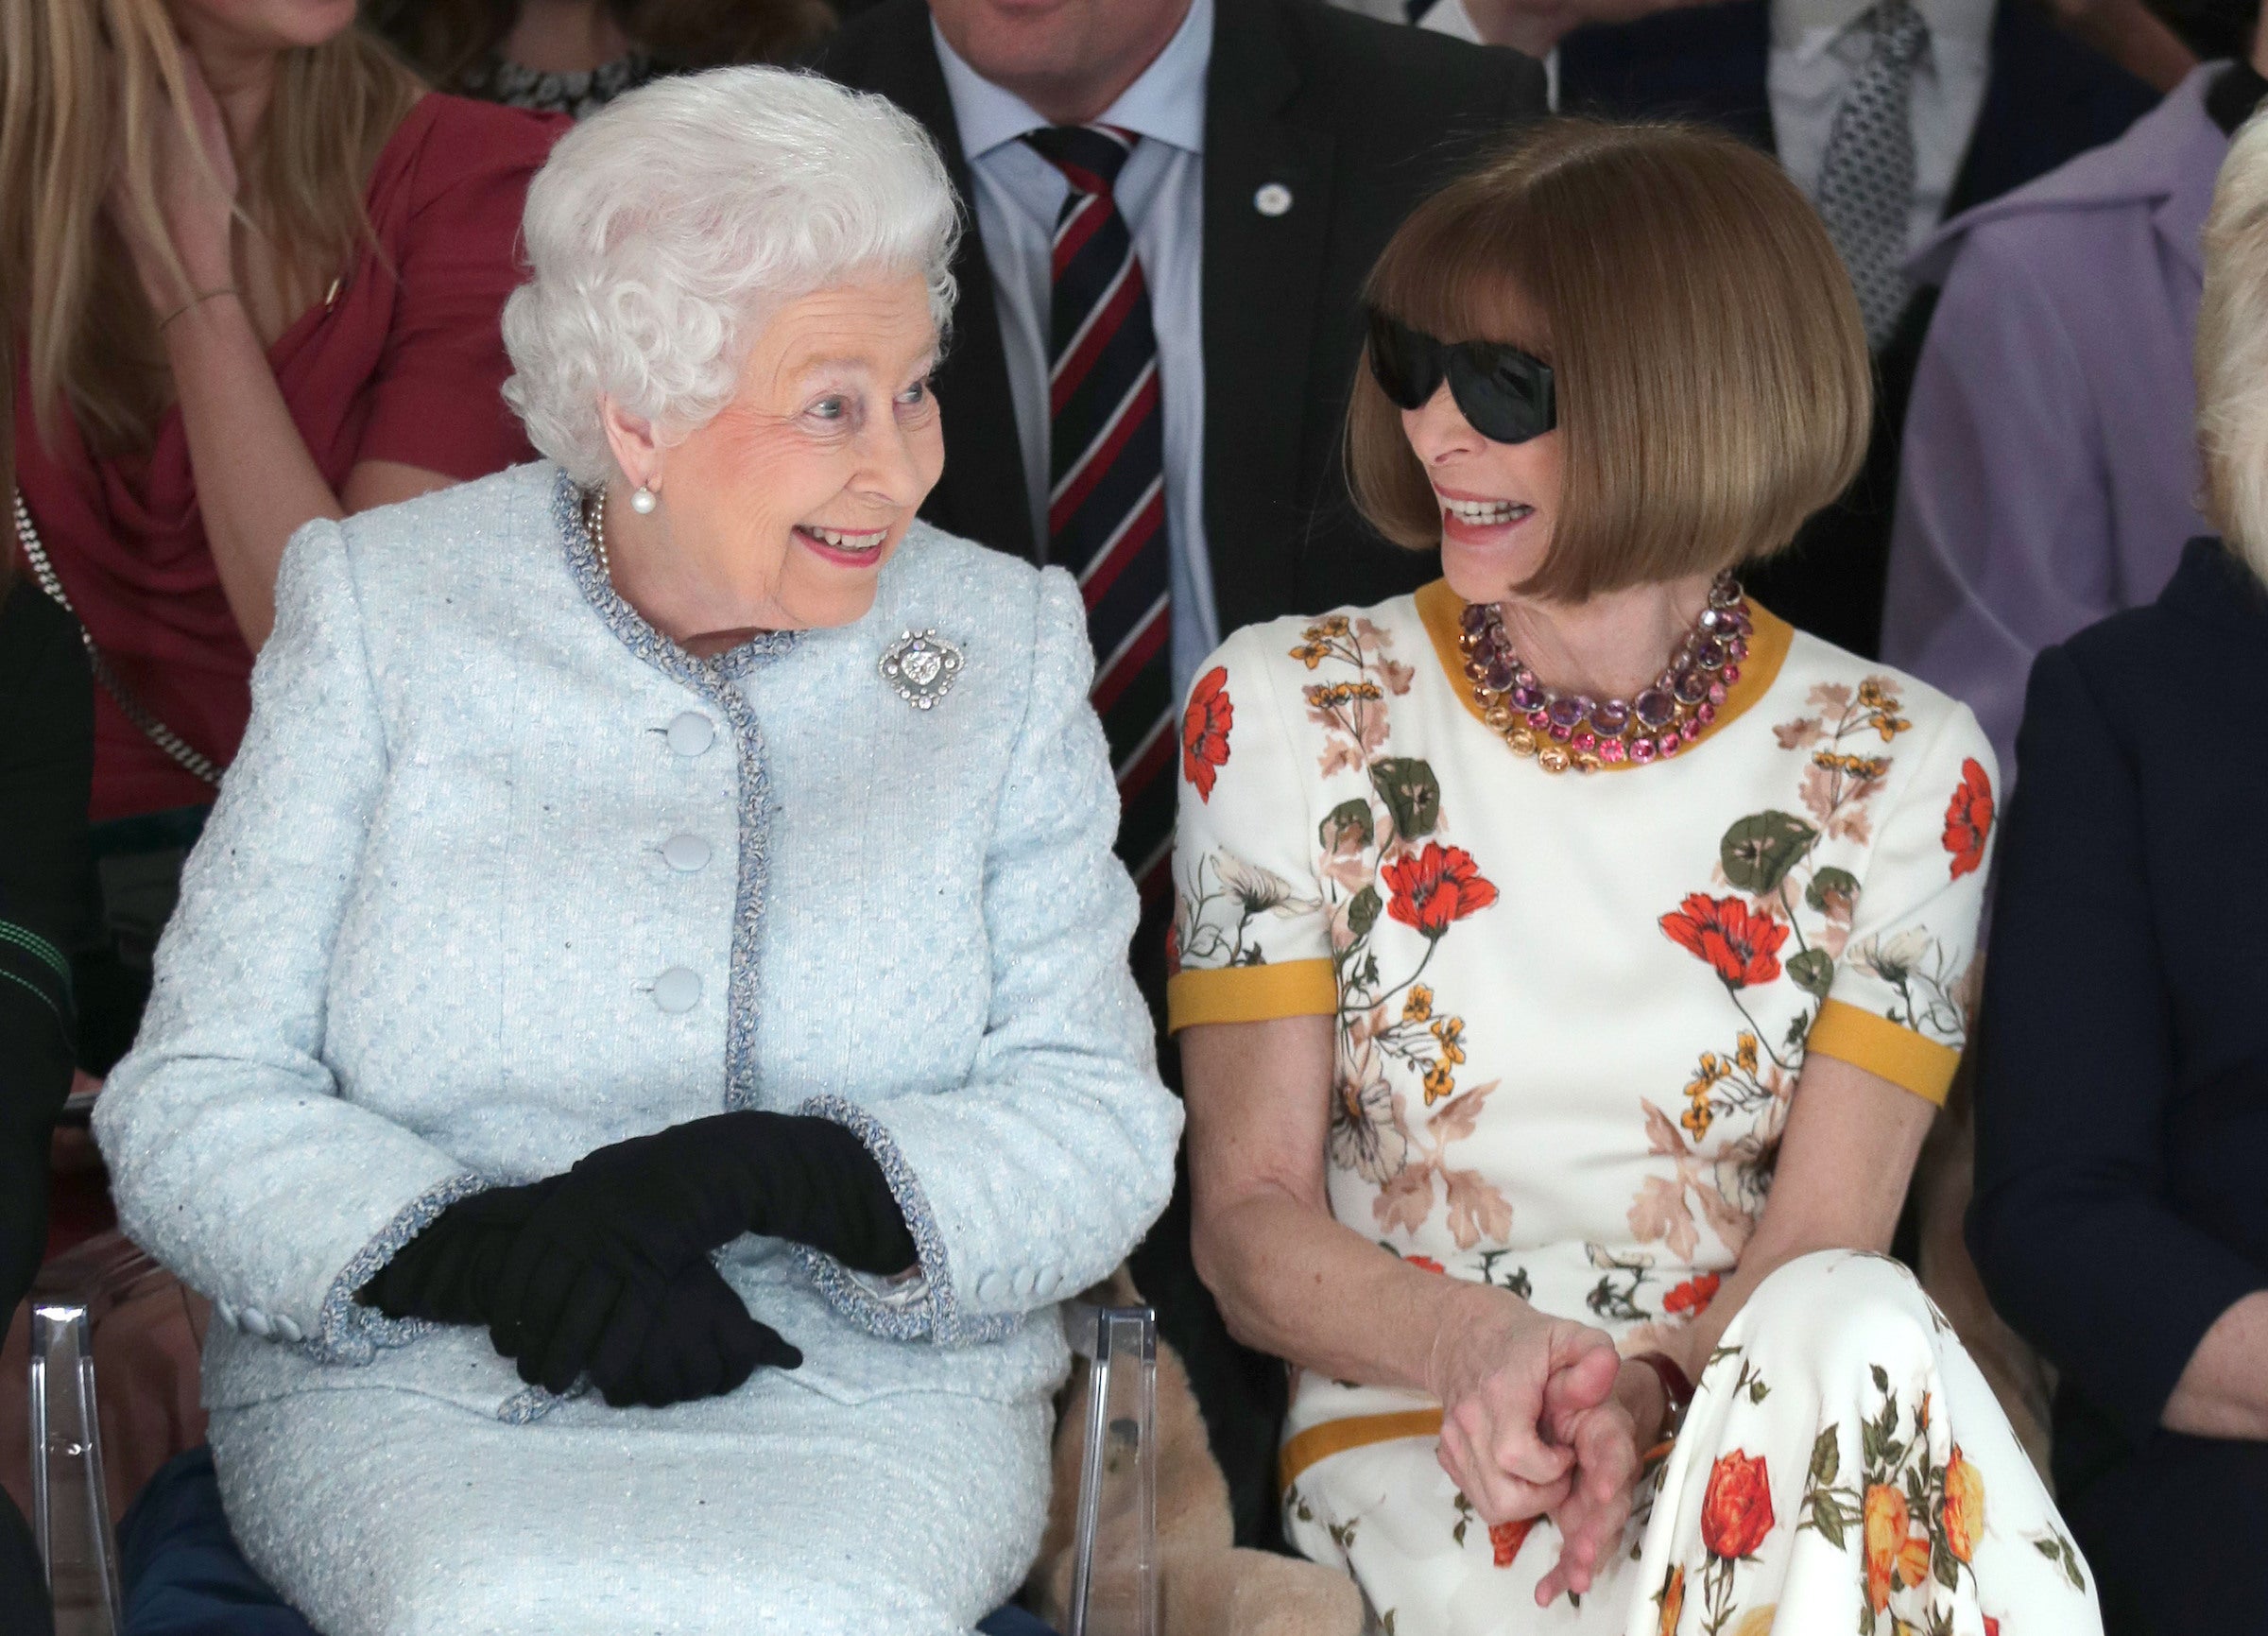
left=608, top=275, right=946, bottom=635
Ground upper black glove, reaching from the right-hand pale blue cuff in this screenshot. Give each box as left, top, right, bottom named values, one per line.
left=492, top=1110, right=914, bottom=1385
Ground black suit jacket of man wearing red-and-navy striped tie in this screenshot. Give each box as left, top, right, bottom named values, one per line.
left=816, top=0, right=1544, bottom=633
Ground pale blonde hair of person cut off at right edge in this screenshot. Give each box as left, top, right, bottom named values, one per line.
left=2195, top=115, right=2268, bottom=578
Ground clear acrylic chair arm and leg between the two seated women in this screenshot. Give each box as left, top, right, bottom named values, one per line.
left=1066, top=1307, right=1159, bottom=1636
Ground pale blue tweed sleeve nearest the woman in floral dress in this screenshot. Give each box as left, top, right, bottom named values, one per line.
left=799, top=572, right=1181, bottom=1346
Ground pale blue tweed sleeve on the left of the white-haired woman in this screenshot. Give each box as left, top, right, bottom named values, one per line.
left=95, top=520, right=481, bottom=1361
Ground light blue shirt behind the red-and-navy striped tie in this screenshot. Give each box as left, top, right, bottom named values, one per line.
left=930, top=0, right=1220, bottom=695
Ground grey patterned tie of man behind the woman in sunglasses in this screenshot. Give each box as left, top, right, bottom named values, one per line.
left=1819, top=0, right=1930, bottom=347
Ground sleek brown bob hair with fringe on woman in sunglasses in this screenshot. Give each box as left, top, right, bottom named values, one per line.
left=1348, top=118, right=1873, bottom=601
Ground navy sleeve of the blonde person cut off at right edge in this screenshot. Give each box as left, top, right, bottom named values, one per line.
left=1968, top=649, right=2268, bottom=1441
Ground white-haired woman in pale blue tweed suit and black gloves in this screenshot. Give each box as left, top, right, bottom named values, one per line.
left=97, top=68, right=1179, bottom=1636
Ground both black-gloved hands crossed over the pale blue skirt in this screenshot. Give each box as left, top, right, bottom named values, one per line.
left=358, top=1110, right=914, bottom=1409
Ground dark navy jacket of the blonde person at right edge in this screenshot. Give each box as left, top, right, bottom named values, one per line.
left=1968, top=540, right=2268, bottom=1495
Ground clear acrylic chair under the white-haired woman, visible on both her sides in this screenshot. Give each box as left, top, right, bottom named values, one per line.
left=32, top=1232, right=1159, bottom=1636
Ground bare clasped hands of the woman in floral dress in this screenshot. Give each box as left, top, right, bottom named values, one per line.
left=1429, top=1286, right=1667, bottom=1607
